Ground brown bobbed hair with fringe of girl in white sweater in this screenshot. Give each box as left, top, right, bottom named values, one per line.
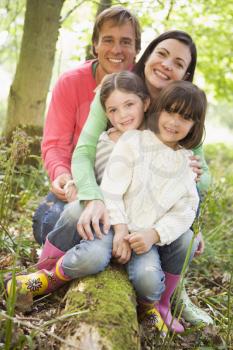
left=146, top=80, right=207, bottom=149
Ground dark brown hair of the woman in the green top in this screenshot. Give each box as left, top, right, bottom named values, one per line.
left=133, top=30, right=197, bottom=81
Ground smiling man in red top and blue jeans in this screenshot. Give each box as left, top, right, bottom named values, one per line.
left=33, top=7, right=141, bottom=244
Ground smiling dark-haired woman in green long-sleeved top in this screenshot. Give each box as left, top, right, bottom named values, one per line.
left=72, top=30, right=212, bottom=323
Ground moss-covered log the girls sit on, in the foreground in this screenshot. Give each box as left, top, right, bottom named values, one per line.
left=61, top=266, right=140, bottom=350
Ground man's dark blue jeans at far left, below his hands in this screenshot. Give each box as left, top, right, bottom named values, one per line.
left=32, top=192, right=66, bottom=245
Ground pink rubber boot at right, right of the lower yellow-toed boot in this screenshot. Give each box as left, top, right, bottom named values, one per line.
left=158, top=272, right=184, bottom=333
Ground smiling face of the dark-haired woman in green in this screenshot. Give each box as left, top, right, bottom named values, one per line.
left=144, top=39, right=191, bottom=97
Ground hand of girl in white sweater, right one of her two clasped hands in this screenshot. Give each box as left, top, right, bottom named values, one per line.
left=124, top=229, right=160, bottom=254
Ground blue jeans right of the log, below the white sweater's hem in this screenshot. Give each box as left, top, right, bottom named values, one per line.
left=126, top=230, right=198, bottom=302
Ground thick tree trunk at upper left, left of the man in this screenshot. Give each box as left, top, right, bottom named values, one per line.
left=5, top=0, right=64, bottom=134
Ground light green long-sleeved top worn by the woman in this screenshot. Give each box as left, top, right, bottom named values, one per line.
left=71, top=90, right=211, bottom=201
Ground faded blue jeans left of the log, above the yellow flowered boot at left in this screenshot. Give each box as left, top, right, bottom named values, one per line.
left=47, top=201, right=113, bottom=279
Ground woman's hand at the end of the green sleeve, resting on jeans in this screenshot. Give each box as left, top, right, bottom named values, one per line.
left=77, top=200, right=110, bottom=240
